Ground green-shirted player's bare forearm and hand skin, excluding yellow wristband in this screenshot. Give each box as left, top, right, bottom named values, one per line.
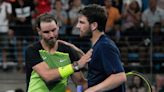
left=33, top=50, right=92, bottom=82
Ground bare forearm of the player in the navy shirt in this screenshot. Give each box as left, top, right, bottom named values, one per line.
left=85, top=72, right=126, bottom=92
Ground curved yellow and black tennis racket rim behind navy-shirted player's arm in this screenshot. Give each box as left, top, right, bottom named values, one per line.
left=126, top=71, right=152, bottom=92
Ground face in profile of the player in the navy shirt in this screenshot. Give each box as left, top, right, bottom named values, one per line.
left=76, top=15, right=92, bottom=37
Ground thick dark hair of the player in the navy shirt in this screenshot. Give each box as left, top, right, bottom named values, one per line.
left=79, top=4, right=107, bottom=31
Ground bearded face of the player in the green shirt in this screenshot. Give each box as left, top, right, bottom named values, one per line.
left=38, top=21, right=59, bottom=46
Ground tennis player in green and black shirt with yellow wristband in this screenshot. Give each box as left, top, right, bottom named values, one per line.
left=25, top=13, right=92, bottom=92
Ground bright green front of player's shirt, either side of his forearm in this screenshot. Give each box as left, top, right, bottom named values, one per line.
left=28, top=50, right=71, bottom=92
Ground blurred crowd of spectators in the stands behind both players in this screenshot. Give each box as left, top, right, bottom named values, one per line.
left=0, top=0, right=164, bottom=92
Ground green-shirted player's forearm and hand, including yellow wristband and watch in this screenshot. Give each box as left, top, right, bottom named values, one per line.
left=33, top=50, right=92, bottom=82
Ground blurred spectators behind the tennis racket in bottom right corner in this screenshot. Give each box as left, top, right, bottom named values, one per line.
left=126, top=74, right=164, bottom=92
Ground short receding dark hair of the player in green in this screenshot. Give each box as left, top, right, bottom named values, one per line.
left=35, top=13, right=57, bottom=28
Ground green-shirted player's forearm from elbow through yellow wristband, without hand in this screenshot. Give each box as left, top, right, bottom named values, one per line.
left=33, top=62, right=74, bottom=82
